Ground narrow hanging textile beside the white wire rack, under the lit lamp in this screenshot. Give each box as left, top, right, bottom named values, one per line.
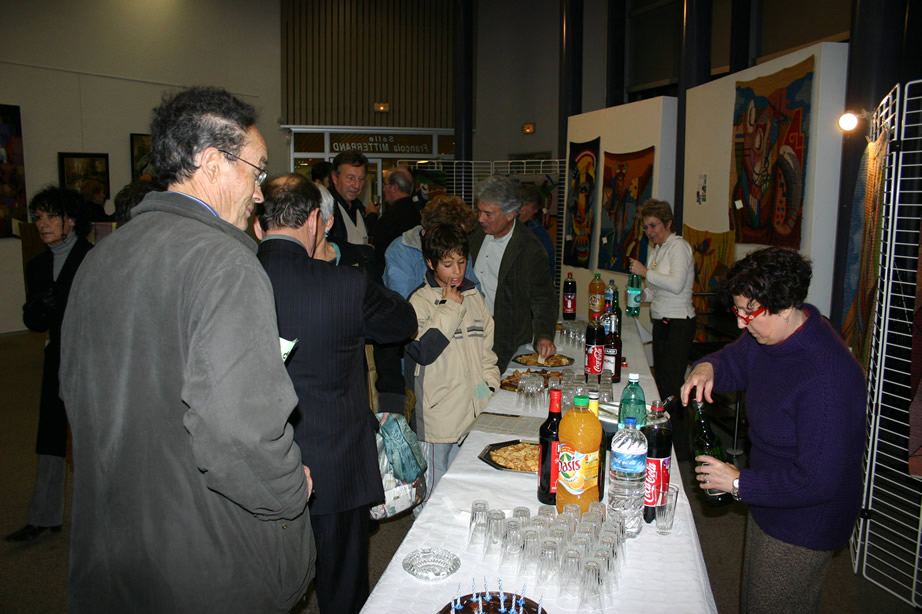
left=842, top=130, right=890, bottom=372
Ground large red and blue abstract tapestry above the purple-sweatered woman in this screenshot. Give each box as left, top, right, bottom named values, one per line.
left=729, top=56, right=813, bottom=248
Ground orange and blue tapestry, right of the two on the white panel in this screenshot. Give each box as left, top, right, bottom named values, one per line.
left=599, top=147, right=654, bottom=273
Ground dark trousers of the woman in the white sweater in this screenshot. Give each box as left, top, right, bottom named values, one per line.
left=653, top=318, right=696, bottom=460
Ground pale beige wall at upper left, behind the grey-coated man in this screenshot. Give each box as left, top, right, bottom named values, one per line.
left=0, top=0, right=289, bottom=332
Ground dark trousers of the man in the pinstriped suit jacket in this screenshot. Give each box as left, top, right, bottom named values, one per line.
left=311, top=505, right=370, bottom=614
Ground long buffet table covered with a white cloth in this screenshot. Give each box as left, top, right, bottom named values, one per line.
left=362, top=320, right=717, bottom=614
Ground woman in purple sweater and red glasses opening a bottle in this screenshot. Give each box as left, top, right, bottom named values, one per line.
left=681, top=247, right=866, bottom=612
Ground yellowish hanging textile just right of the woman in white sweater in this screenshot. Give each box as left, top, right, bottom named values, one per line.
left=682, top=224, right=736, bottom=343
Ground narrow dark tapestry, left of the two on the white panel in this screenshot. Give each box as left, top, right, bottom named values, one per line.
left=563, top=137, right=602, bottom=269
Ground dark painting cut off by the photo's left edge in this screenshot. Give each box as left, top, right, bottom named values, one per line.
left=0, top=104, right=28, bottom=238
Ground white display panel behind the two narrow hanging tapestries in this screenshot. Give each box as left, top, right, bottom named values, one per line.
left=557, top=97, right=678, bottom=319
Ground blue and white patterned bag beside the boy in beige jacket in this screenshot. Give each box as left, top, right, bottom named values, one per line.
left=370, top=412, right=427, bottom=520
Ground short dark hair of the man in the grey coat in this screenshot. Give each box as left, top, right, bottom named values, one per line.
left=150, top=87, right=256, bottom=187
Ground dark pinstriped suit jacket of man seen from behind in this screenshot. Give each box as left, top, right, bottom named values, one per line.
left=258, top=239, right=416, bottom=514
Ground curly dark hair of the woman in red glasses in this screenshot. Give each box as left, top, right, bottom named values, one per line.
left=722, top=247, right=813, bottom=313
